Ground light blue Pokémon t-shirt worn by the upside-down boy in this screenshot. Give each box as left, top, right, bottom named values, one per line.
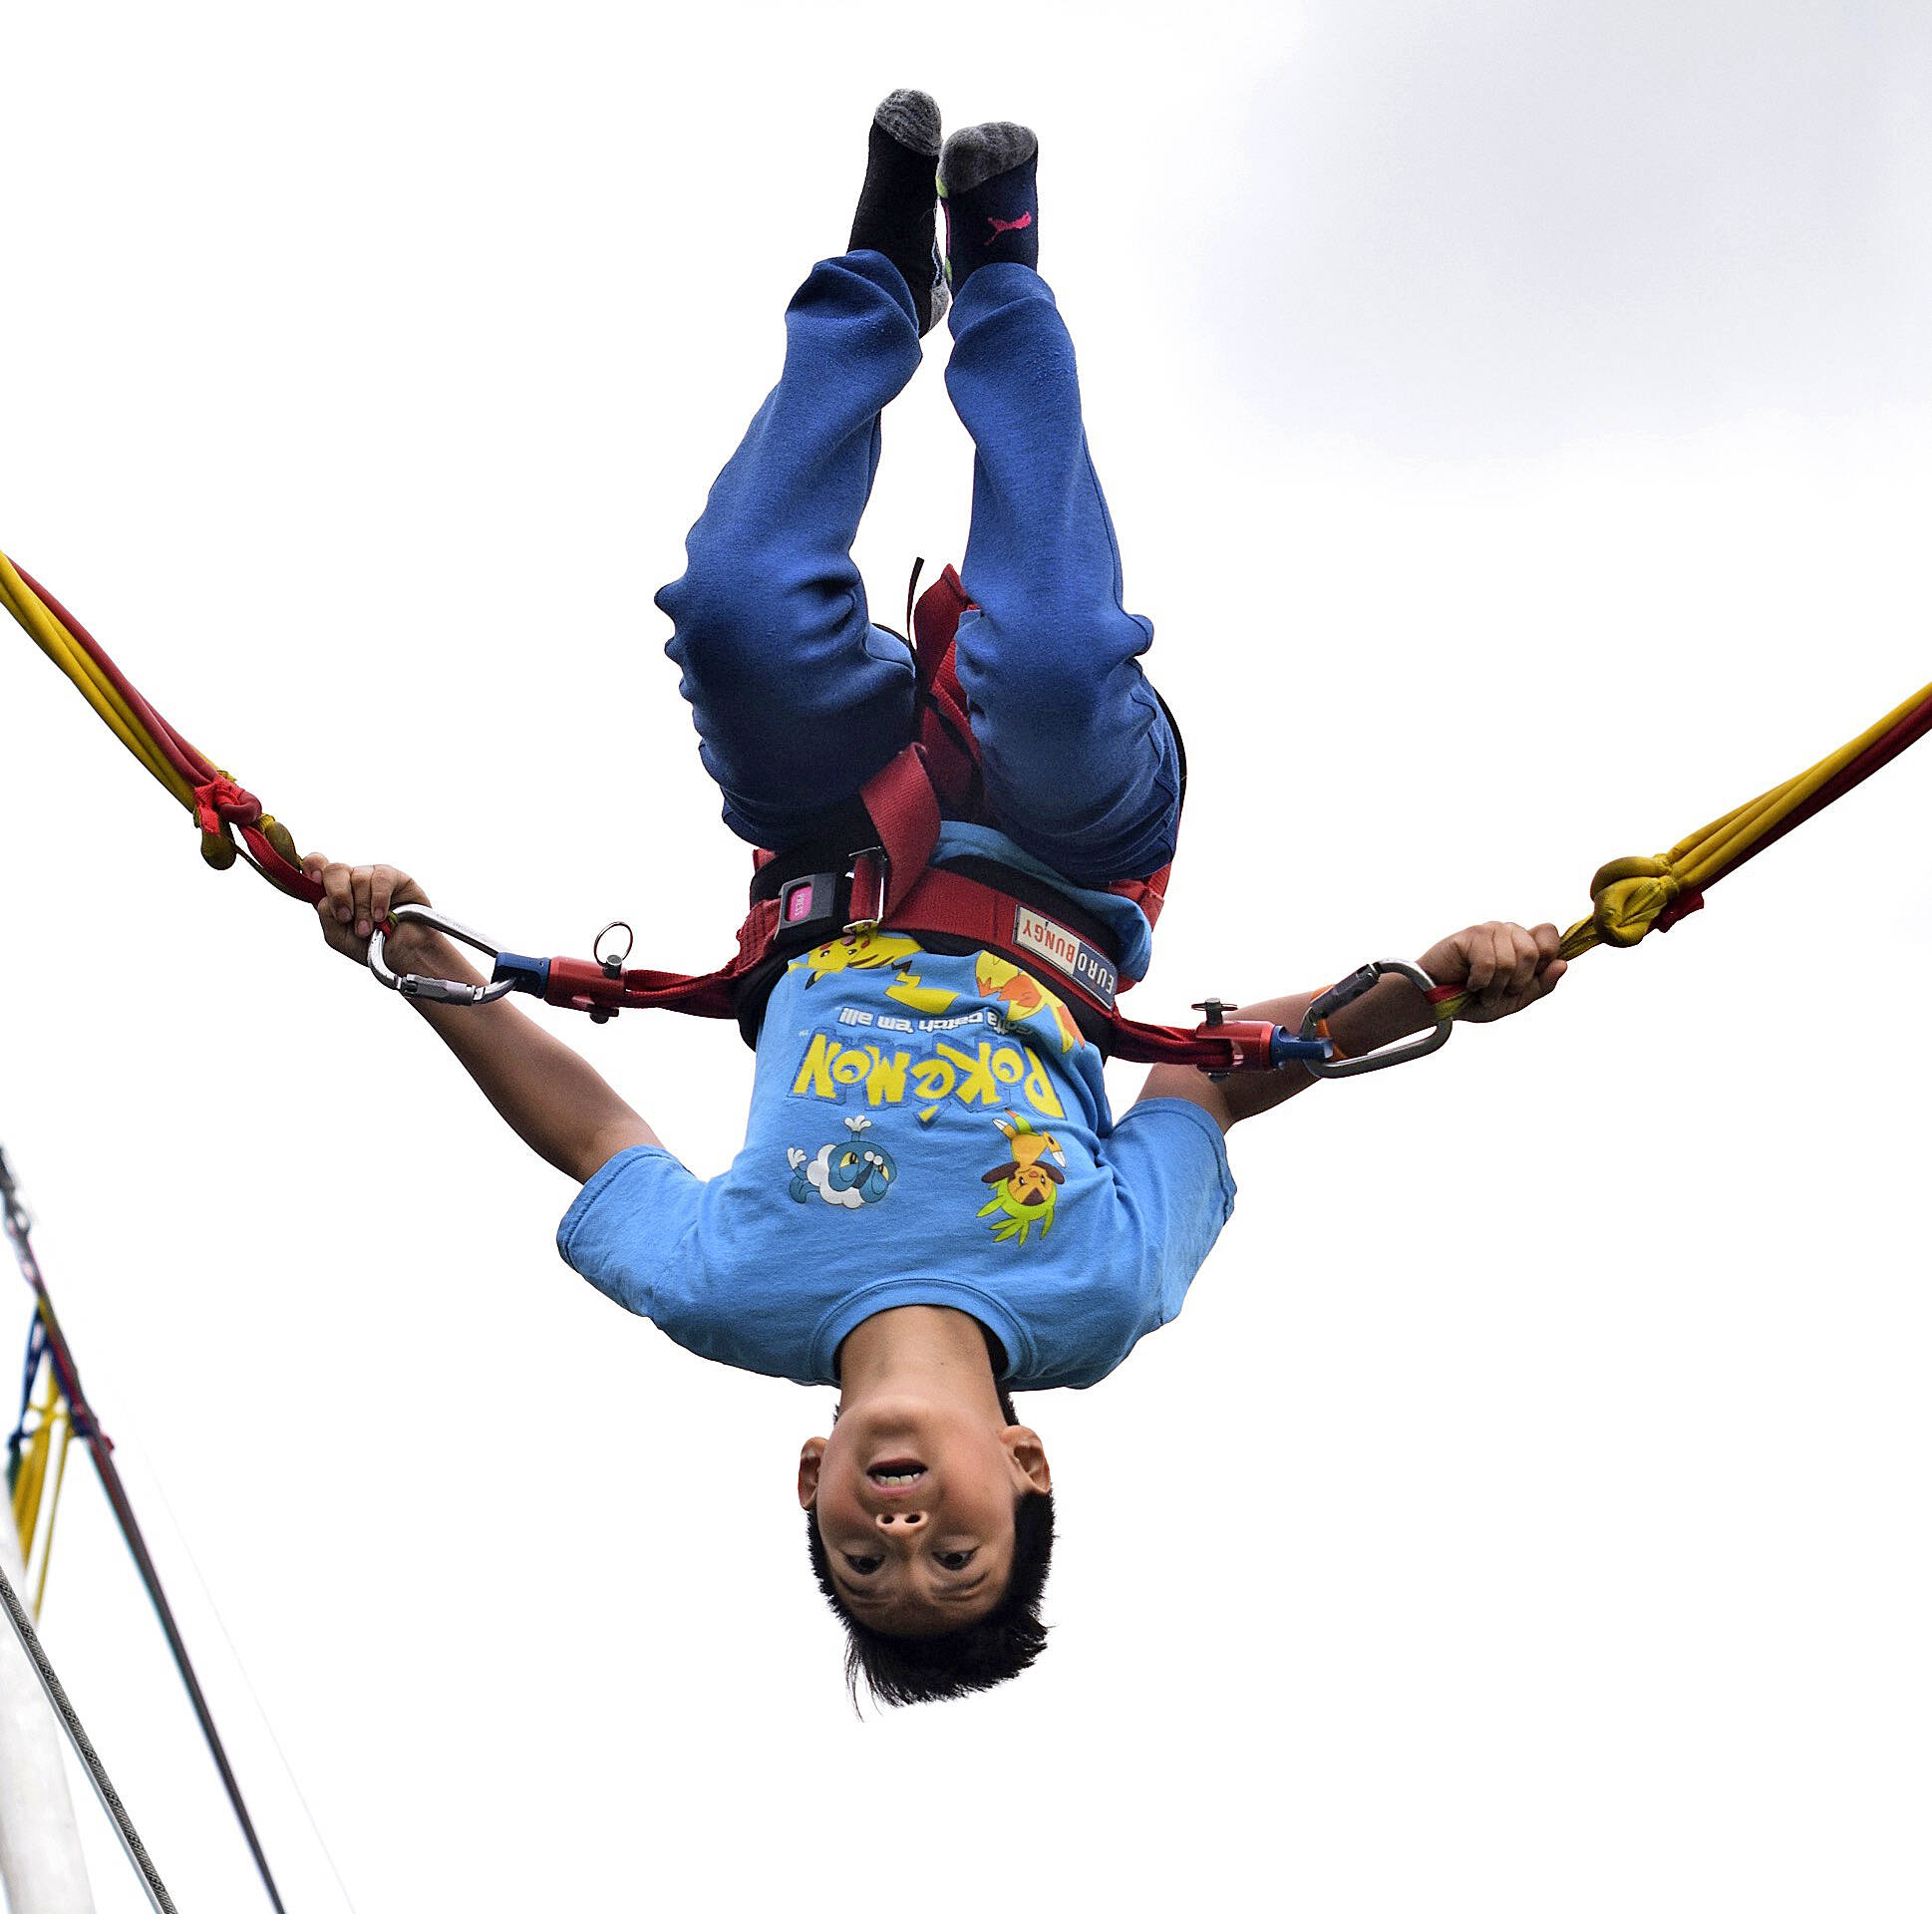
left=556, top=884, right=1234, bottom=1389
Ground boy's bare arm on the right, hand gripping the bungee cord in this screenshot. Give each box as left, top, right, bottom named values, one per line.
left=1136, top=923, right=1569, bottom=1129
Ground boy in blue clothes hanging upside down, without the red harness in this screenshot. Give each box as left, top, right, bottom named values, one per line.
left=307, top=93, right=1563, bottom=1702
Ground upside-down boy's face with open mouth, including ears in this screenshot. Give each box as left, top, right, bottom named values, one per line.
left=798, top=1397, right=1053, bottom=1636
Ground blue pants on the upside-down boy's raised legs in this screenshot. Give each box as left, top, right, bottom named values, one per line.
left=657, top=253, right=1180, bottom=884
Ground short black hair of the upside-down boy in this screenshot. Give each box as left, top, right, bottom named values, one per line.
left=805, top=1387, right=1053, bottom=1708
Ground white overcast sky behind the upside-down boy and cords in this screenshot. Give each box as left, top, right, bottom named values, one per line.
left=0, top=0, right=1932, bottom=1914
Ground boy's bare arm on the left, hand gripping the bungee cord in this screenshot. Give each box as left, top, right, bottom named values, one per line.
left=301, top=851, right=657, bottom=1182
